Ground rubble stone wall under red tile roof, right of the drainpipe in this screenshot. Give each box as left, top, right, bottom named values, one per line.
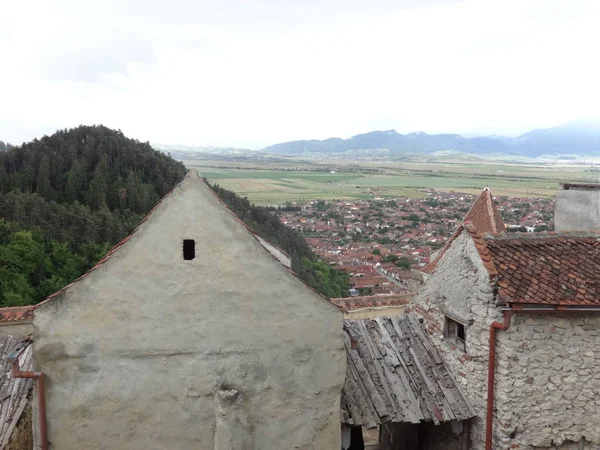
left=495, top=312, right=600, bottom=450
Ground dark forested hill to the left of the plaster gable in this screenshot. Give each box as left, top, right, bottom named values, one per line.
left=0, top=126, right=185, bottom=306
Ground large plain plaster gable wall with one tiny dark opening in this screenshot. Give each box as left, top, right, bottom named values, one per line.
left=34, top=173, right=345, bottom=450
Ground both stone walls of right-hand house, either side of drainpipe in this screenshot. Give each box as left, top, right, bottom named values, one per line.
left=409, top=233, right=600, bottom=450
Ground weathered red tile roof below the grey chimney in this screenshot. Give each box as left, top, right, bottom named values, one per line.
left=483, top=233, right=600, bottom=306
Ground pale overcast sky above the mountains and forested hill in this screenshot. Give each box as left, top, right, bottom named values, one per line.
left=0, top=0, right=600, bottom=148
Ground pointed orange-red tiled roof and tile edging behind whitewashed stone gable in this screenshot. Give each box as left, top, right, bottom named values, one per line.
left=421, top=188, right=506, bottom=274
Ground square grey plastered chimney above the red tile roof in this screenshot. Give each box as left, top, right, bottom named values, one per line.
left=554, top=183, right=600, bottom=231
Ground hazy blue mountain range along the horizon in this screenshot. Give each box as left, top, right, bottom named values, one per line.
left=262, top=121, right=600, bottom=158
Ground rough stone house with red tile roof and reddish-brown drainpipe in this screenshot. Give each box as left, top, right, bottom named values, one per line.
left=407, top=185, right=600, bottom=450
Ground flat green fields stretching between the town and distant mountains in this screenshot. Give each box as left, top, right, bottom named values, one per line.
left=186, top=161, right=600, bottom=205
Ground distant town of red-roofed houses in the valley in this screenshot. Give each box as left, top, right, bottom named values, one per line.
left=278, top=189, right=555, bottom=299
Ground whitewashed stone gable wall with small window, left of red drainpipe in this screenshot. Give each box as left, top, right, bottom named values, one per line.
left=408, top=231, right=502, bottom=450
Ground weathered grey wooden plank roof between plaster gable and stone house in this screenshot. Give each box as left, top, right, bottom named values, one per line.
left=341, top=314, right=475, bottom=428
